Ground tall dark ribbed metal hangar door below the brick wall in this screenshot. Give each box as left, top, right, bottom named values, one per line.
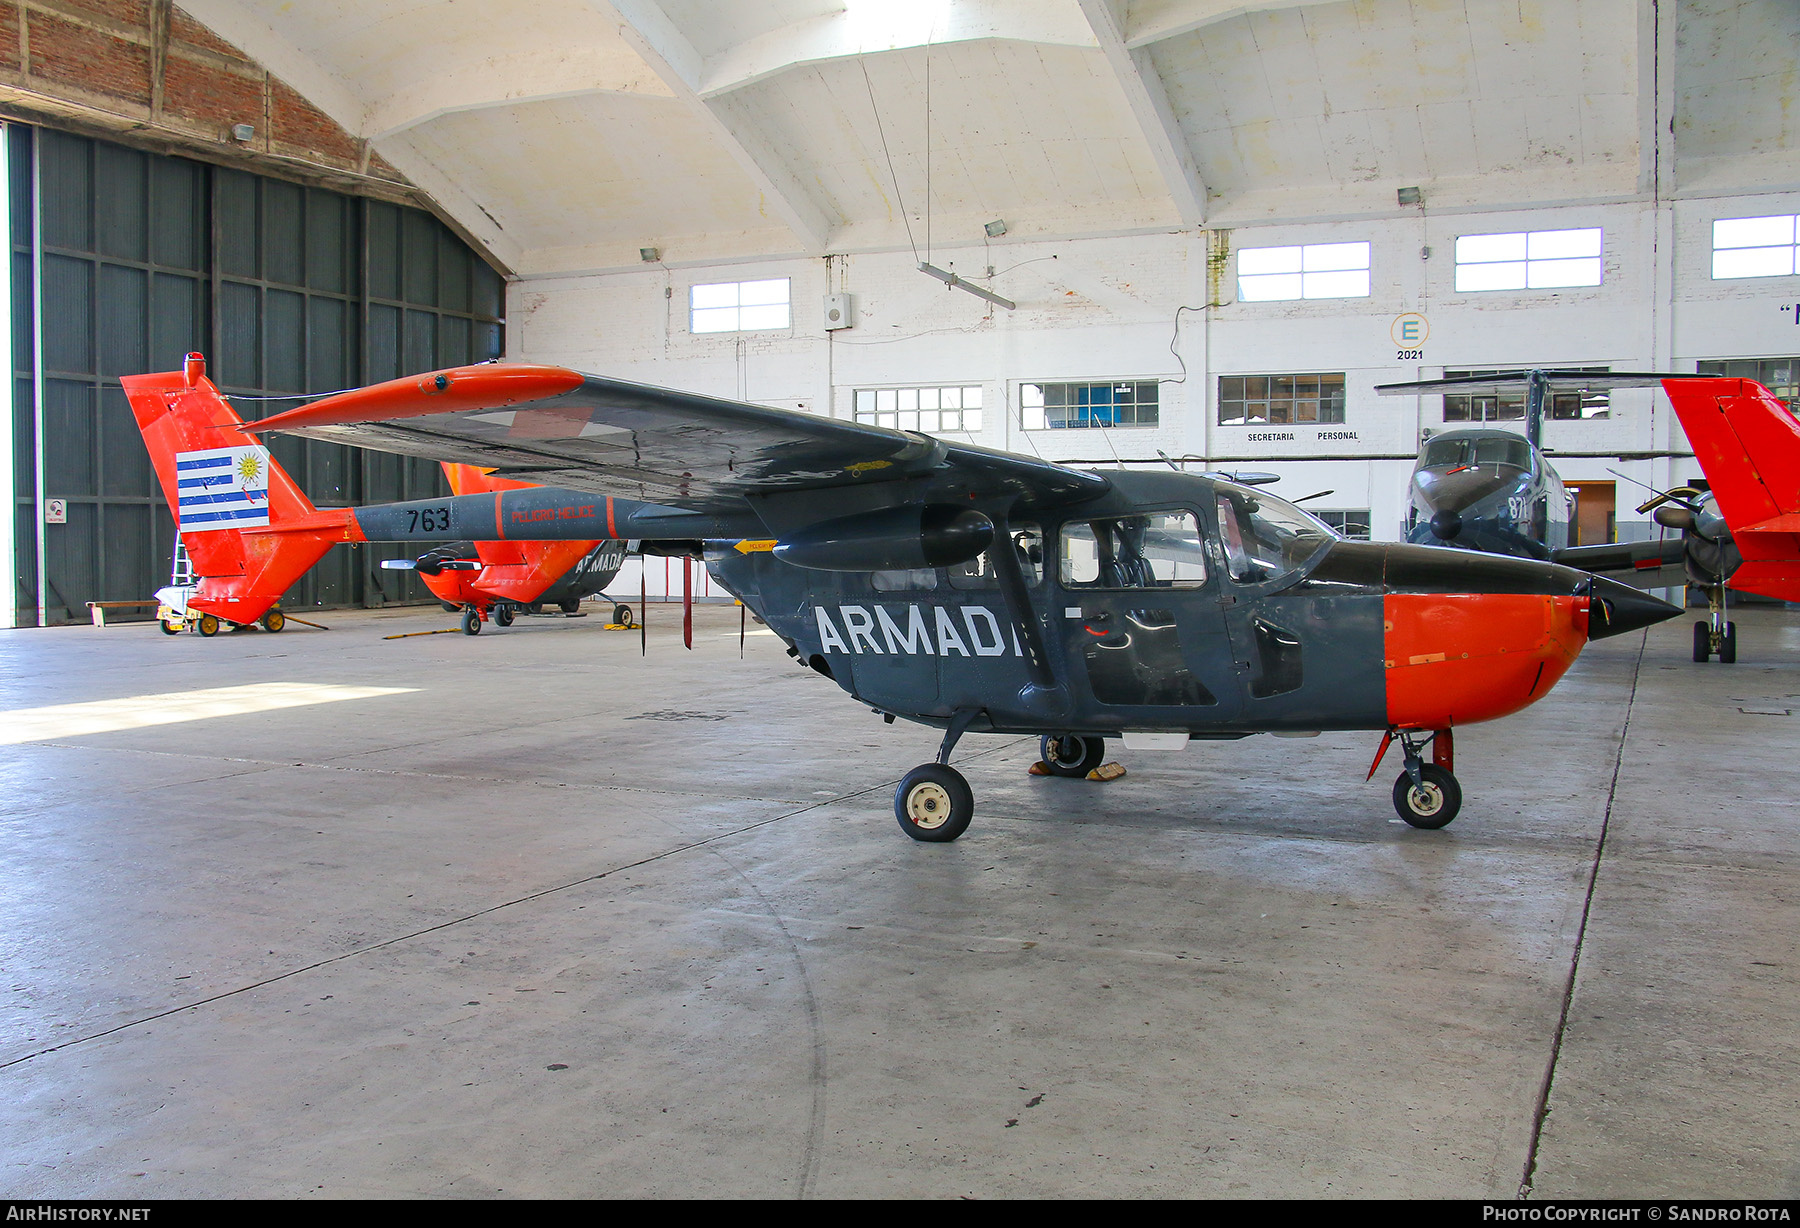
left=5, top=126, right=504, bottom=627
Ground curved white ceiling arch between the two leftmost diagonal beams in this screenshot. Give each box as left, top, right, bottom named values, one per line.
left=362, top=47, right=673, bottom=140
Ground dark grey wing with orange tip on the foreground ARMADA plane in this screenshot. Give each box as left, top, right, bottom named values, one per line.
left=247, top=364, right=1111, bottom=513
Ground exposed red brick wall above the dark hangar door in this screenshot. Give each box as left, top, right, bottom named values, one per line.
left=0, top=0, right=409, bottom=194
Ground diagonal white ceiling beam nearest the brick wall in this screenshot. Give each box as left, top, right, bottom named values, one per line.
left=170, top=0, right=526, bottom=268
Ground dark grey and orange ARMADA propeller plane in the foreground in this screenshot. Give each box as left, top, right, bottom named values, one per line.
left=136, top=349, right=1678, bottom=841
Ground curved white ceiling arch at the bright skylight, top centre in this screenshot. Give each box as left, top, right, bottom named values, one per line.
left=700, top=0, right=1094, bottom=99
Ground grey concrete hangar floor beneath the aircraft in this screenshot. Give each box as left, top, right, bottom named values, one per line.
left=0, top=607, right=1800, bottom=1199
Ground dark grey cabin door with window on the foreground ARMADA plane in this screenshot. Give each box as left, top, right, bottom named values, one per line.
left=1057, top=508, right=1242, bottom=729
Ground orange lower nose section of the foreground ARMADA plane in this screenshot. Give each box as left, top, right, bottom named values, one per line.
left=1382, top=592, right=1588, bottom=729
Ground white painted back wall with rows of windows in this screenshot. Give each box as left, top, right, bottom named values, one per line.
left=508, top=193, right=1800, bottom=592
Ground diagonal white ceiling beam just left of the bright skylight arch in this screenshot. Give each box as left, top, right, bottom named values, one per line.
left=594, top=0, right=833, bottom=256
